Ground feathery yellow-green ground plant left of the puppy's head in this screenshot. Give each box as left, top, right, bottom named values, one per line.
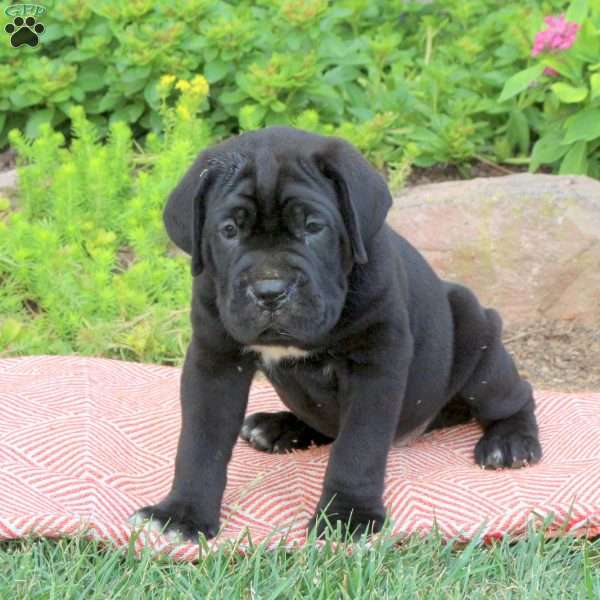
left=0, top=78, right=213, bottom=363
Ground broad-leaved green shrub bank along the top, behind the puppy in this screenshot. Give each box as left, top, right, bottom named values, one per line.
left=0, top=0, right=580, bottom=173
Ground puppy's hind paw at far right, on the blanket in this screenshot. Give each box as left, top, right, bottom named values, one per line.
left=475, top=431, right=542, bottom=469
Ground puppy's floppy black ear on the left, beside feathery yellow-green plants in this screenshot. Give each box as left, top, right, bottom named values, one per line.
left=163, top=156, right=211, bottom=277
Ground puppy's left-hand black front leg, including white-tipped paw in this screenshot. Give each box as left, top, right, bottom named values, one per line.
left=130, top=338, right=254, bottom=541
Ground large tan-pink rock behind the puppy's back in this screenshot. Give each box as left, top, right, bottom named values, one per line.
left=388, top=174, right=600, bottom=326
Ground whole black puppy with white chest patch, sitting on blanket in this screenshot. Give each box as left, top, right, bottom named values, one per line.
left=132, top=127, right=541, bottom=538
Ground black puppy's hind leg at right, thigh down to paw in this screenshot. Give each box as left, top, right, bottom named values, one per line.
left=453, top=288, right=542, bottom=469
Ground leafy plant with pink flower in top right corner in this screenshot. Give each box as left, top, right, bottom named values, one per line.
left=500, top=0, right=600, bottom=177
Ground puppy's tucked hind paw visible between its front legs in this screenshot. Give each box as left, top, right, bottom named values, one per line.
left=240, top=411, right=333, bottom=454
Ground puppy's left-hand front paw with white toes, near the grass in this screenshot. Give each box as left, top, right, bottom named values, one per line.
left=127, top=500, right=219, bottom=543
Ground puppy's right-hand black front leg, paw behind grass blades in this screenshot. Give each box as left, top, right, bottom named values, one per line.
left=310, top=352, right=409, bottom=535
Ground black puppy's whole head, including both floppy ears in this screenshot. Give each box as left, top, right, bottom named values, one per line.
left=164, top=127, right=391, bottom=349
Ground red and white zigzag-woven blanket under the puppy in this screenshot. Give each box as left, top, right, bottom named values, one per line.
left=0, top=356, right=600, bottom=560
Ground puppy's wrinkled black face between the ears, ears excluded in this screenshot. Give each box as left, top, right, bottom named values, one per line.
left=202, top=158, right=351, bottom=345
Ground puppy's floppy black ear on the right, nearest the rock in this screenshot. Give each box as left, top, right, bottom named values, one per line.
left=315, top=138, right=392, bottom=264
